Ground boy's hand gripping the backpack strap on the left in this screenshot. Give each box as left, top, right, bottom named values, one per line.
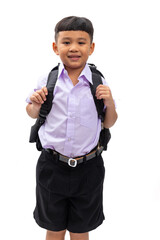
left=30, top=87, right=48, bottom=105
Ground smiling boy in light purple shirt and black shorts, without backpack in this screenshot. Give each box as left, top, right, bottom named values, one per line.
left=26, top=17, right=117, bottom=240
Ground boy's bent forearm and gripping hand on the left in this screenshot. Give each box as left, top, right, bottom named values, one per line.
left=26, top=87, right=48, bottom=118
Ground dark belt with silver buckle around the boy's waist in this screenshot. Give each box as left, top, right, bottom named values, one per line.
left=45, top=147, right=103, bottom=167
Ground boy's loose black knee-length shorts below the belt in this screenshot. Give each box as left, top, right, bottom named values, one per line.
left=34, top=150, right=105, bottom=233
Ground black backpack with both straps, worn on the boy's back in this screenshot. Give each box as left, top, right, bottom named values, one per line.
left=29, top=64, right=111, bottom=151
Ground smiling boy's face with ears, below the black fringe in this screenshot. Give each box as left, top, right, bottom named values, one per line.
left=53, top=31, right=94, bottom=70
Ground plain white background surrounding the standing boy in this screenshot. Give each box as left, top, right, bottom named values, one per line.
left=0, top=0, right=160, bottom=240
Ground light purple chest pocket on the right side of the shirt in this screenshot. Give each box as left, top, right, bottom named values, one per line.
left=80, top=97, right=98, bottom=129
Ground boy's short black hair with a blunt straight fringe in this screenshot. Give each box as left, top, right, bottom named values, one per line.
left=55, top=16, right=94, bottom=42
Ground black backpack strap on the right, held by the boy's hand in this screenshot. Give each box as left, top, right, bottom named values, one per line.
left=89, top=64, right=104, bottom=122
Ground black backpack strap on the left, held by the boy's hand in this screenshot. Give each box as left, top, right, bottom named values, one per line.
left=39, top=64, right=59, bottom=120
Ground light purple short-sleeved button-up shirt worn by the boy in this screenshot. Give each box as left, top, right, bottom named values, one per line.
left=27, top=64, right=108, bottom=157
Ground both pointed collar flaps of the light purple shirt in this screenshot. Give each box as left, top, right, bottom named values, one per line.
left=58, top=63, right=93, bottom=84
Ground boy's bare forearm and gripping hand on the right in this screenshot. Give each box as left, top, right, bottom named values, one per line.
left=96, top=85, right=118, bottom=128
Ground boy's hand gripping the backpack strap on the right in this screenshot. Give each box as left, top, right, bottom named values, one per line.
left=96, top=84, right=114, bottom=107
